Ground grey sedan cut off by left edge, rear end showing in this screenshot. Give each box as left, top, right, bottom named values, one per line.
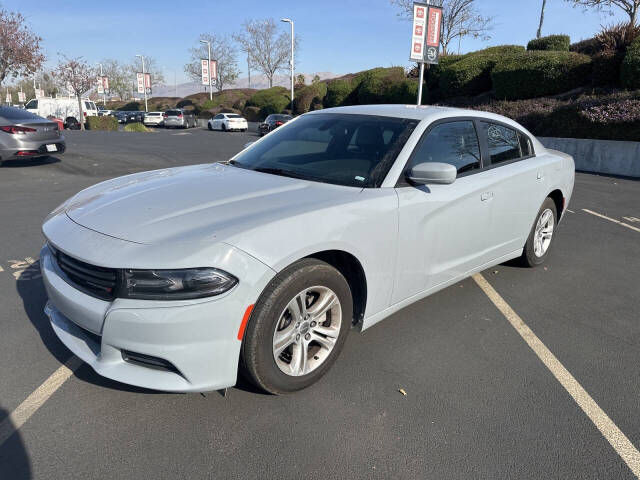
left=0, top=107, right=66, bottom=161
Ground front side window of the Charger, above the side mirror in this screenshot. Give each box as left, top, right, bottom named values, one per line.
left=411, top=120, right=480, bottom=173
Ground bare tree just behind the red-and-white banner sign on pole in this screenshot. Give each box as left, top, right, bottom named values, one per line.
left=391, top=0, right=493, bottom=55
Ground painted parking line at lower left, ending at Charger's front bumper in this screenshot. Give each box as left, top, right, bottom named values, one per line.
left=0, top=355, right=82, bottom=447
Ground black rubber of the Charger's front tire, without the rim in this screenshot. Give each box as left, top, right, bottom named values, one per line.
left=243, top=259, right=353, bottom=394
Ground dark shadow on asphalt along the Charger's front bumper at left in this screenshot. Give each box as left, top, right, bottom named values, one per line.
left=16, top=261, right=166, bottom=396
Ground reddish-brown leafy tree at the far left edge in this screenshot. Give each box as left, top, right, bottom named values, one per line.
left=0, top=9, right=44, bottom=85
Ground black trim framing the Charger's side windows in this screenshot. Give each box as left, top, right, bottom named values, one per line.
left=395, top=116, right=536, bottom=188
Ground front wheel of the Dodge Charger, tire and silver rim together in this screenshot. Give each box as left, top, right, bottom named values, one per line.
left=242, top=258, right=353, bottom=395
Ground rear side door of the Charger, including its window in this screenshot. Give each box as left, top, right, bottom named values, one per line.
left=478, top=120, right=547, bottom=258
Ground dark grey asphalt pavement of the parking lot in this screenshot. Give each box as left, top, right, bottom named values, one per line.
left=0, top=125, right=640, bottom=479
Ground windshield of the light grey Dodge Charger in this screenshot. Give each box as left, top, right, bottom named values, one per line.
left=230, top=113, right=418, bottom=188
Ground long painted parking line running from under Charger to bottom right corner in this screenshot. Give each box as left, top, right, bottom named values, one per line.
left=472, top=273, right=640, bottom=478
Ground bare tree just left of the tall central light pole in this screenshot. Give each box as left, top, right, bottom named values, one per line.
left=233, top=18, right=299, bottom=87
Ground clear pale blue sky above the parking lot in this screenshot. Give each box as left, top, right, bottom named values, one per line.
left=5, top=0, right=628, bottom=83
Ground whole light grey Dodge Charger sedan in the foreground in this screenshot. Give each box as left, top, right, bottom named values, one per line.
left=40, top=105, right=574, bottom=393
